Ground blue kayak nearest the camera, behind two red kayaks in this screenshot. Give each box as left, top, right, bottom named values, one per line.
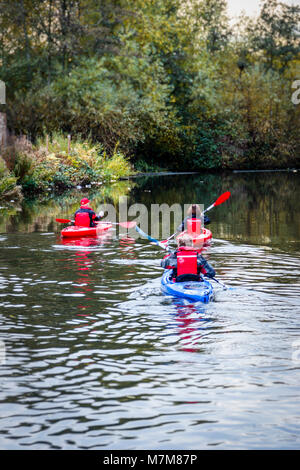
left=161, top=269, right=214, bottom=303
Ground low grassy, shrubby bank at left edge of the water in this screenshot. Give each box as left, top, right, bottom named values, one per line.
left=0, top=133, right=134, bottom=199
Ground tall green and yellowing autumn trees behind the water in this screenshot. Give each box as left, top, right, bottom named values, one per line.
left=0, top=0, right=300, bottom=171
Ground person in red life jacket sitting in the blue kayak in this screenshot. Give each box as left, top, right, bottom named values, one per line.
left=161, top=234, right=216, bottom=282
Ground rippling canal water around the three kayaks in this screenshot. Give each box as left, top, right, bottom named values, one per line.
left=0, top=172, right=300, bottom=450
